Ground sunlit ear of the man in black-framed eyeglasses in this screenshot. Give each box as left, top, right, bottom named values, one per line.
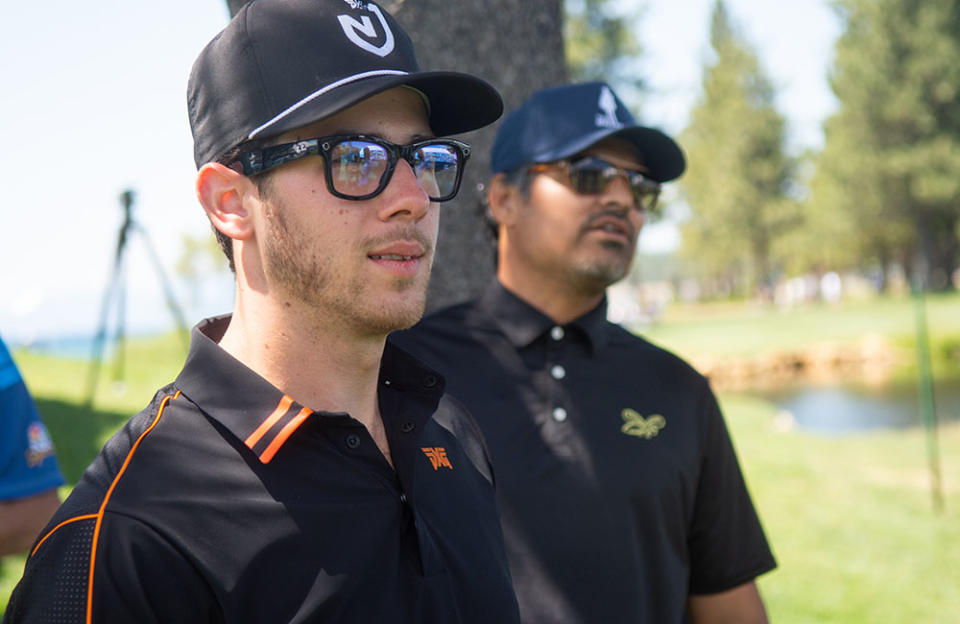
left=197, top=163, right=256, bottom=240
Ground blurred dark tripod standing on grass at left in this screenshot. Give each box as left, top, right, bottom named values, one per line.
left=85, top=189, right=189, bottom=408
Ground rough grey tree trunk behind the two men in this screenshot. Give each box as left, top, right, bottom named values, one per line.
left=227, top=0, right=567, bottom=310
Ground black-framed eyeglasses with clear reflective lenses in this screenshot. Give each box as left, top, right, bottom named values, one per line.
left=237, top=134, right=470, bottom=202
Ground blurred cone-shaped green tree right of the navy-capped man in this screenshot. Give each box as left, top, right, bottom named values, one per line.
left=681, top=0, right=798, bottom=294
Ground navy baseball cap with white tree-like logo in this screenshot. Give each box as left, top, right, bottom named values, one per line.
left=490, top=82, right=686, bottom=182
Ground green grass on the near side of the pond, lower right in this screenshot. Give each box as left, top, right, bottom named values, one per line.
left=721, top=395, right=960, bottom=624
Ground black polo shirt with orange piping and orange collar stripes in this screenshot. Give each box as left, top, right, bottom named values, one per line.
left=4, top=318, right=518, bottom=624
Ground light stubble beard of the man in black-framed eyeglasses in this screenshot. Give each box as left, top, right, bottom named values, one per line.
left=264, top=200, right=433, bottom=337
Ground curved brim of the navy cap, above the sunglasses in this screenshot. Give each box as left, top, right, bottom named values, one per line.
left=535, top=126, right=687, bottom=182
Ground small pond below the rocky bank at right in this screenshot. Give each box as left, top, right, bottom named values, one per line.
left=758, top=380, right=960, bottom=433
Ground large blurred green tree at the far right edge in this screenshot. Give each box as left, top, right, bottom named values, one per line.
left=808, top=0, right=960, bottom=287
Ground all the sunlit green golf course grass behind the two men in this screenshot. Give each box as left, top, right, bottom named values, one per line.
left=0, top=295, right=960, bottom=624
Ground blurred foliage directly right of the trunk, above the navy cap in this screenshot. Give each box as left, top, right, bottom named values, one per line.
left=563, top=0, right=644, bottom=103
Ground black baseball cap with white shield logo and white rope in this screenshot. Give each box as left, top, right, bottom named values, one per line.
left=187, top=0, right=503, bottom=168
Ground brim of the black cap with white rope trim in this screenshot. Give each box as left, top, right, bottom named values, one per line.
left=250, top=72, right=503, bottom=143
